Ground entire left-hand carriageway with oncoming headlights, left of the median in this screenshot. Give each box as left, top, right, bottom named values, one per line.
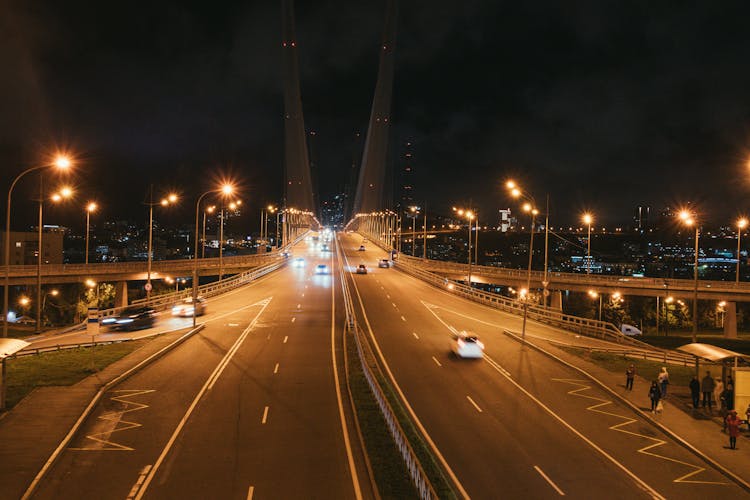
left=34, top=239, right=368, bottom=499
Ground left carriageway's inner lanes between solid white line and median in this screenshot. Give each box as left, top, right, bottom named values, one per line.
left=147, top=244, right=352, bottom=498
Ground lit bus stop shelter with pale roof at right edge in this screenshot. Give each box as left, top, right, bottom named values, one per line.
left=677, top=343, right=750, bottom=415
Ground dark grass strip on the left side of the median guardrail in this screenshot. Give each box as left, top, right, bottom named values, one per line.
left=346, top=333, right=418, bottom=498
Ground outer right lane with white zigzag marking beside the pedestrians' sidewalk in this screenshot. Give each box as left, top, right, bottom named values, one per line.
left=428, top=304, right=744, bottom=498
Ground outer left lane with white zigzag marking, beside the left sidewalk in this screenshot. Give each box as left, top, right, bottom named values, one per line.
left=28, top=274, right=290, bottom=498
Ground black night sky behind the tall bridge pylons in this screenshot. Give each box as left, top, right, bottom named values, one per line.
left=0, top=0, right=750, bottom=231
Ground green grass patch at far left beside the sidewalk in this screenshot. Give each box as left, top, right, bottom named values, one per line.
left=6, top=339, right=150, bottom=409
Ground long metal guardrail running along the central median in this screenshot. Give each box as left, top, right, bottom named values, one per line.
left=336, top=236, right=438, bottom=500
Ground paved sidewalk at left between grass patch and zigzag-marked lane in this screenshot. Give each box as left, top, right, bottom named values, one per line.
left=0, top=330, right=191, bottom=500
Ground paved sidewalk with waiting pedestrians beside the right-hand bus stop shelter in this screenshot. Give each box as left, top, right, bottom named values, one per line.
left=533, top=340, right=750, bottom=490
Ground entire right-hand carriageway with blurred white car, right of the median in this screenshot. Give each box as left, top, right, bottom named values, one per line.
left=341, top=234, right=746, bottom=498
